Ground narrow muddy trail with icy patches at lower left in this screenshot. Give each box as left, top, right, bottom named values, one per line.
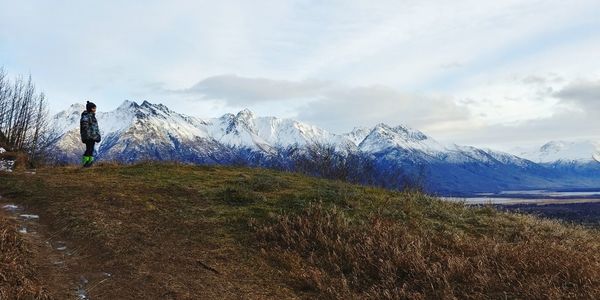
left=0, top=198, right=113, bottom=299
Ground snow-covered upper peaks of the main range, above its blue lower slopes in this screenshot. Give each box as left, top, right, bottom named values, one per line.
left=53, top=101, right=516, bottom=162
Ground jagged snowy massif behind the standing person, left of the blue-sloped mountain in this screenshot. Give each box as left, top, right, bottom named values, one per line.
left=53, top=101, right=355, bottom=162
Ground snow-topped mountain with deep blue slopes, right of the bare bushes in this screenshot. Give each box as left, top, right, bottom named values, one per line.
left=340, top=124, right=556, bottom=193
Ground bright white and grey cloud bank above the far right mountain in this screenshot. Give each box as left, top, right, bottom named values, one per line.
left=438, top=73, right=600, bottom=151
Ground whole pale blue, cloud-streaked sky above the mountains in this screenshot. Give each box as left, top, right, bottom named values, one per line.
left=0, top=0, right=600, bottom=150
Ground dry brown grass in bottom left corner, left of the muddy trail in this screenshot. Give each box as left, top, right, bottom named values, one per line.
left=0, top=213, right=50, bottom=299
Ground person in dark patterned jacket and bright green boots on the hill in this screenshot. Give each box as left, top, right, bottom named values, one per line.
left=80, top=101, right=101, bottom=168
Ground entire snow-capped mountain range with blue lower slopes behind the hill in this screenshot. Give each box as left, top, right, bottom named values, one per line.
left=51, top=101, right=600, bottom=194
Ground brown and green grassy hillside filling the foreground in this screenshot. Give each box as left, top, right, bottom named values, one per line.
left=0, top=164, right=600, bottom=299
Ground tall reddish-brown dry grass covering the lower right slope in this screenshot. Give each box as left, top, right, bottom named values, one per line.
left=258, top=200, right=600, bottom=299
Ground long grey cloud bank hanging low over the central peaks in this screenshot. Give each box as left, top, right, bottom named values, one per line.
left=178, top=75, right=469, bottom=131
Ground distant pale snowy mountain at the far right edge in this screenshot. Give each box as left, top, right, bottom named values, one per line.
left=518, top=140, right=600, bottom=164
